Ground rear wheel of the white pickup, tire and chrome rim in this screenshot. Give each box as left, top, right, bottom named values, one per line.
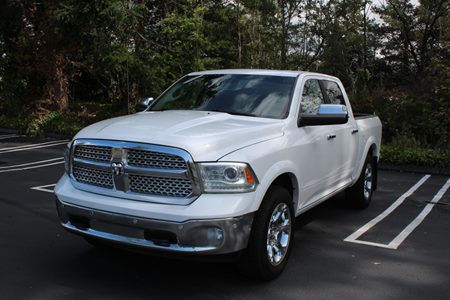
left=346, top=154, right=376, bottom=209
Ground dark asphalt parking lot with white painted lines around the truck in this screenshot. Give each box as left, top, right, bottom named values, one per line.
left=0, top=132, right=450, bottom=299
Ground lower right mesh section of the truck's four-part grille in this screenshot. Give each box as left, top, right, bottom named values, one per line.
left=129, top=175, right=192, bottom=197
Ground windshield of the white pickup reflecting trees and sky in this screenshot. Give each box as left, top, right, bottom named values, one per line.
left=150, top=74, right=296, bottom=119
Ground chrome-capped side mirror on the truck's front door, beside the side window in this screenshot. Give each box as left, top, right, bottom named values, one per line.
left=298, top=104, right=348, bottom=126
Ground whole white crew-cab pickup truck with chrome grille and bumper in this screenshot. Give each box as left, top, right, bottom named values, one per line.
left=55, top=70, right=381, bottom=280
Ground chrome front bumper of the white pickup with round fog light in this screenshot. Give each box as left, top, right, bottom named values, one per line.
left=56, top=199, right=253, bottom=255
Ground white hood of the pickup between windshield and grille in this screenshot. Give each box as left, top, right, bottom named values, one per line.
left=75, top=110, right=285, bottom=161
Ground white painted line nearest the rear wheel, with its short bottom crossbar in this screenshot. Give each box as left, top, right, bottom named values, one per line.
left=344, top=175, right=431, bottom=249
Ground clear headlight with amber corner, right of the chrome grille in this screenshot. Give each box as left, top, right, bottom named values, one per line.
left=198, top=162, right=258, bottom=193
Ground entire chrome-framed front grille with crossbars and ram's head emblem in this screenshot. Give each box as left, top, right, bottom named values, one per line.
left=71, top=139, right=200, bottom=204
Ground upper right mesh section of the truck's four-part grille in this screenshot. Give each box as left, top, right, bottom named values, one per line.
left=128, top=149, right=186, bottom=170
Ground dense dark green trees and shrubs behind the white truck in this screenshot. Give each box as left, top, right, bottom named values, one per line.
left=0, top=0, right=450, bottom=165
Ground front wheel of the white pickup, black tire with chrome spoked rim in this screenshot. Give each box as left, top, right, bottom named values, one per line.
left=238, top=186, right=295, bottom=281
